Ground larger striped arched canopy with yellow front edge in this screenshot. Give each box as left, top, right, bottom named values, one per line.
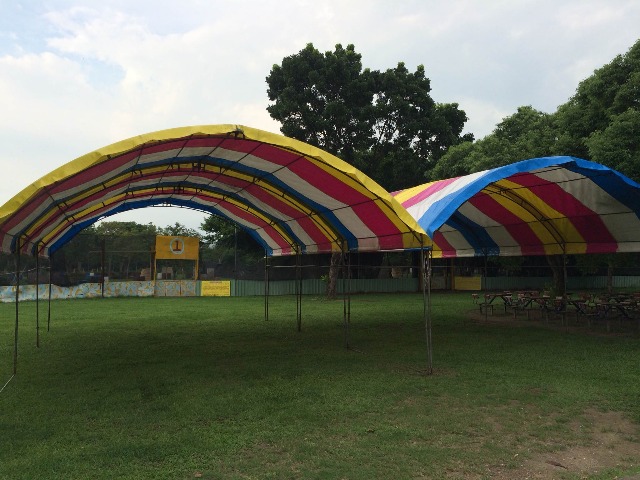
left=0, top=125, right=430, bottom=256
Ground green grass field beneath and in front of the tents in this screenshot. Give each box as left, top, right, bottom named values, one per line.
left=0, top=294, right=640, bottom=479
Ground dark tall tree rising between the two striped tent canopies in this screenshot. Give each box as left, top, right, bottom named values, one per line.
left=267, top=43, right=473, bottom=190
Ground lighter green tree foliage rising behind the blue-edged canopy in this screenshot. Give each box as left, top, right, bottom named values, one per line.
left=436, top=41, right=640, bottom=181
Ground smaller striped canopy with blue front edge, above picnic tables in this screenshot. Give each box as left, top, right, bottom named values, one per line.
left=392, top=157, right=640, bottom=257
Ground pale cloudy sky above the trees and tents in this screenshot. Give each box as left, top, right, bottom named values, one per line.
left=0, top=0, right=640, bottom=232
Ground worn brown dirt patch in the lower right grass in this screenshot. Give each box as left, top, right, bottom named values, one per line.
left=489, top=409, right=640, bottom=480
